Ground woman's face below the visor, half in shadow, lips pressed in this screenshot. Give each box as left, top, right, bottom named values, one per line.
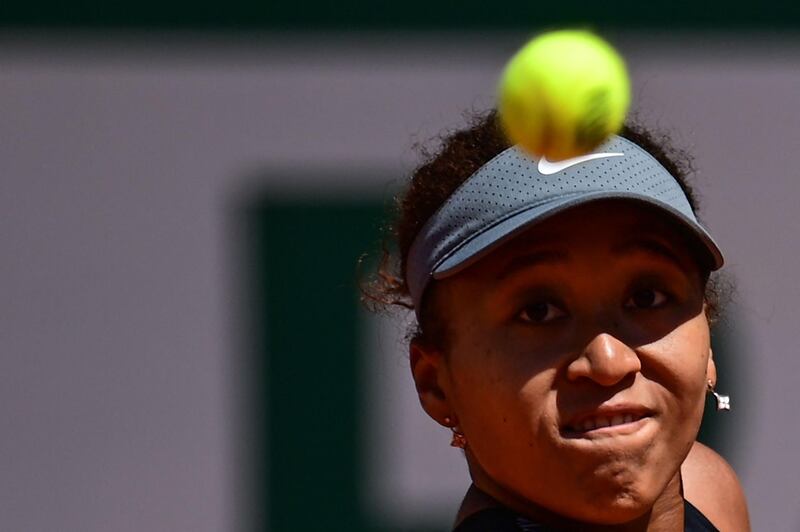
left=424, top=201, right=712, bottom=523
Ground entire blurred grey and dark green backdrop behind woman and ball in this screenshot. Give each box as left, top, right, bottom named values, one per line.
left=0, top=4, right=800, bottom=532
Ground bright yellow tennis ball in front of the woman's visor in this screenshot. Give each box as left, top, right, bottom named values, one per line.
left=498, top=30, right=630, bottom=160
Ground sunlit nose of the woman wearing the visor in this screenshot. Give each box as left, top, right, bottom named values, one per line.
left=567, top=333, right=642, bottom=386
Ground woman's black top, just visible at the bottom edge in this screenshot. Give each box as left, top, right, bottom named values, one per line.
left=453, top=499, right=719, bottom=532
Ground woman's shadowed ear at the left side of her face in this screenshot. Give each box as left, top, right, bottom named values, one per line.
left=409, top=338, right=455, bottom=426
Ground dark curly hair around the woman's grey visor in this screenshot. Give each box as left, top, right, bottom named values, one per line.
left=361, top=109, right=720, bottom=344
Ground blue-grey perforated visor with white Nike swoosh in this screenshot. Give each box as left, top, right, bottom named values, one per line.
left=406, top=136, right=723, bottom=309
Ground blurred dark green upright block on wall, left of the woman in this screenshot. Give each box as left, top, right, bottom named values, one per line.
left=257, top=204, right=379, bottom=532
